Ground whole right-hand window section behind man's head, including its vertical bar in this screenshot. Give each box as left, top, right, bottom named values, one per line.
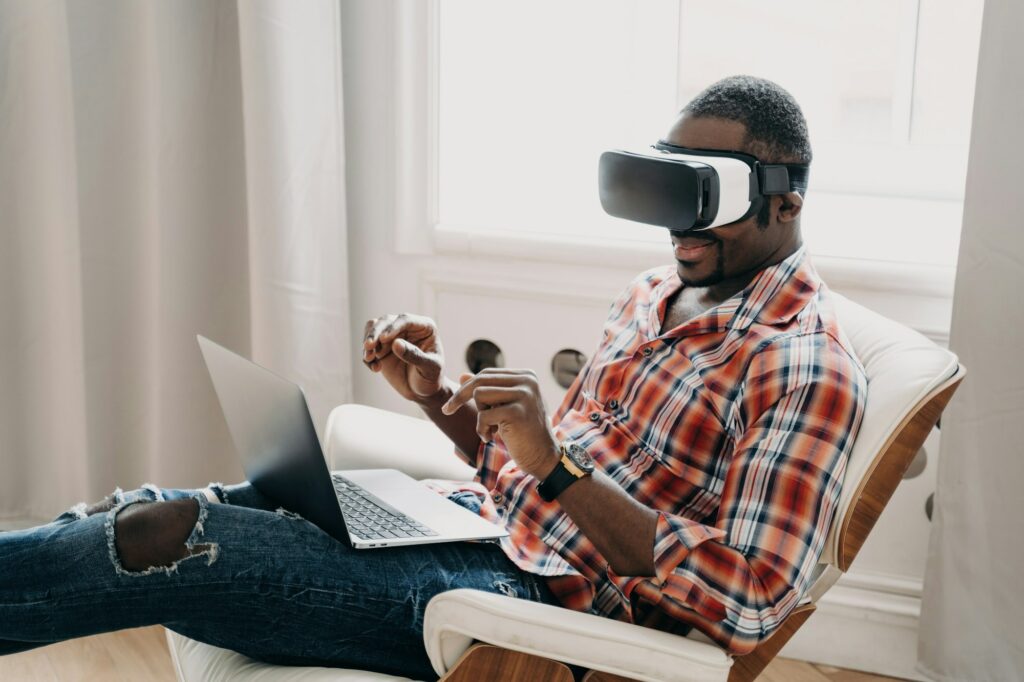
left=679, top=0, right=982, bottom=201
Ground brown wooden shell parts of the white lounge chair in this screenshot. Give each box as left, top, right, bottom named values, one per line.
left=441, top=365, right=966, bottom=682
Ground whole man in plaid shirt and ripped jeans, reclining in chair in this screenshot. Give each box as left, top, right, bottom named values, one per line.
left=0, top=77, right=865, bottom=678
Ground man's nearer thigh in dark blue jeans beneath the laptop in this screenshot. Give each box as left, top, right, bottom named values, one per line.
left=153, top=505, right=552, bottom=679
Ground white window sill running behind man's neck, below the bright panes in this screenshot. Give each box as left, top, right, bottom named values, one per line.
left=433, top=224, right=956, bottom=300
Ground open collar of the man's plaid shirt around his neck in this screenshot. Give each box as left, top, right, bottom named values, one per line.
left=651, top=246, right=821, bottom=336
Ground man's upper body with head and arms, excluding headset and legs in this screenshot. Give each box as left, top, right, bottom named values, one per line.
left=364, top=71, right=866, bottom=653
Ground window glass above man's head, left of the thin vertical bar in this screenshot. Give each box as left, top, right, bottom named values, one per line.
left=679, top=0, right=916, bottom=143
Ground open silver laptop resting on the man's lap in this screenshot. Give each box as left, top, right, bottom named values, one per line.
left=197, top=336, right=508, bottom=549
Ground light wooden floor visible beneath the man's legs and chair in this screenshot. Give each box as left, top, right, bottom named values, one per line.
left=0, top=626, right=909, bottom=682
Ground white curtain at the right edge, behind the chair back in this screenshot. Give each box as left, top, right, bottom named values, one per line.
left=919, top=0, right=1024, bottom=682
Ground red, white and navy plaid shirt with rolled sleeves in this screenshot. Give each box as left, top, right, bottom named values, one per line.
left=448, top=248, right=866, bottom=654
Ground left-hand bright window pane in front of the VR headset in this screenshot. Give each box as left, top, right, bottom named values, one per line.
left=439, top=0, right=678, bottom=241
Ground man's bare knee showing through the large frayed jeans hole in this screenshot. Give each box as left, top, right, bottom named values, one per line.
left=114, top=498, right=212, bottom=571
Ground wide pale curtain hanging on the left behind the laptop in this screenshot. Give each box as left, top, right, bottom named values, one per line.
left=0, top=0, right=352, bottom=519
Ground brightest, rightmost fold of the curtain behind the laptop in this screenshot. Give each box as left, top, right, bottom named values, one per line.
left=239, top=0, right=351, bottom=436
